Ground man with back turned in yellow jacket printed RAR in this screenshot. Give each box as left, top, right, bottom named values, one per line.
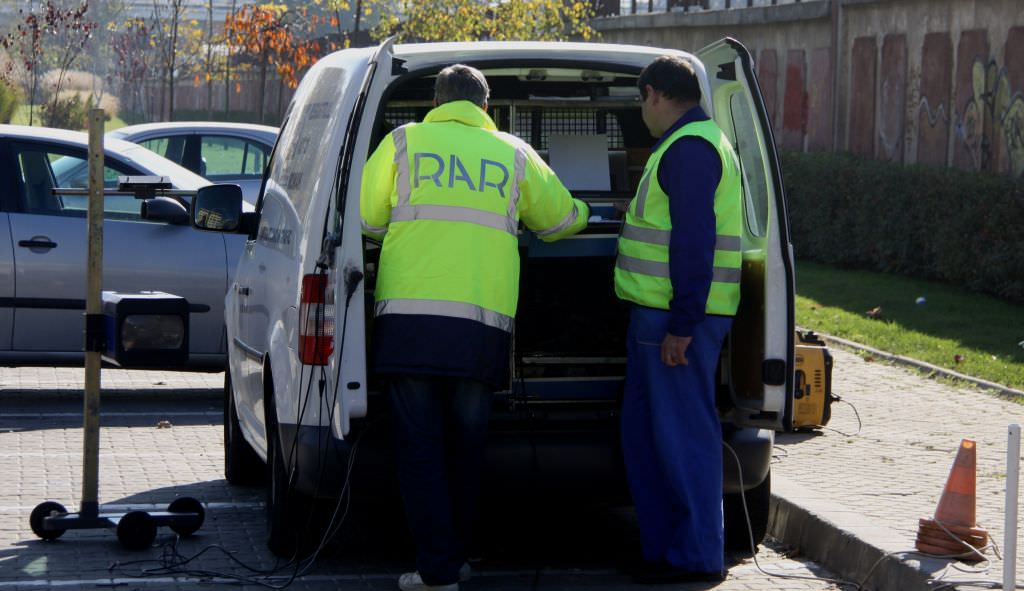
left=360, top=65, right=589, bottom=591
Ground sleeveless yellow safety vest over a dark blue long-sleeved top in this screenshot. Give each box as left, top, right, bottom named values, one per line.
left=615, top=120, right=742, bottom=315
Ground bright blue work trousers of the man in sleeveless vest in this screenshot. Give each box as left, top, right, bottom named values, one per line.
left=623, top=306, right=732, bottom=573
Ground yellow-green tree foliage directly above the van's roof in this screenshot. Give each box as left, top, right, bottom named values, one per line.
left=367, top=0, right=597, bottom=41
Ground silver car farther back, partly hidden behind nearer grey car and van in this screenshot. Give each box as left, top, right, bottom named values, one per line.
left=106, top=121, right=278, bottom=204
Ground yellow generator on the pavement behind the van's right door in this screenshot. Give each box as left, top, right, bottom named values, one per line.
left=783, top=331, right=835, bottom=431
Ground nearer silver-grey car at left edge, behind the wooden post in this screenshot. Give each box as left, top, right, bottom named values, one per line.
left=0, top=125, right=251, bottom=369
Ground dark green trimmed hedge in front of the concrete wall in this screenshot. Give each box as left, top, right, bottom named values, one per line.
left=782, top=153, right=1024, bottom=302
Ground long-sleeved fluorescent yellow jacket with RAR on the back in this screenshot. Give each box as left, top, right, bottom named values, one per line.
left=359, top=100, right=589, bottom=332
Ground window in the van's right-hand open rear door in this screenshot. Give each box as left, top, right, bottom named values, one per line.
left=729, top=92, right=768, bottom=237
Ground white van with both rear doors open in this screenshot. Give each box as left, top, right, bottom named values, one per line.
left=194, top=39, right=794, bottom=555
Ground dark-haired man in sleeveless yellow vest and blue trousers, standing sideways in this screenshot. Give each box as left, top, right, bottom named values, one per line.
left=614, top=55, right=742, bottom=583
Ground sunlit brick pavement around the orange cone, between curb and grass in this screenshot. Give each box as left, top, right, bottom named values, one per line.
left=773, top=348, right=1024, bottom=580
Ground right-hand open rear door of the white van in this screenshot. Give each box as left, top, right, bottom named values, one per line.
left=695, top=38, right=796, bottom=429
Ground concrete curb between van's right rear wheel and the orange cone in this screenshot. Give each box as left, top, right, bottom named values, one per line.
left=768, top=474, right=949, bottom=591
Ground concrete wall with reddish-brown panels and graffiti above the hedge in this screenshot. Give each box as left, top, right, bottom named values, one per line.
left=595, top=0, right=1024, bottom=176
